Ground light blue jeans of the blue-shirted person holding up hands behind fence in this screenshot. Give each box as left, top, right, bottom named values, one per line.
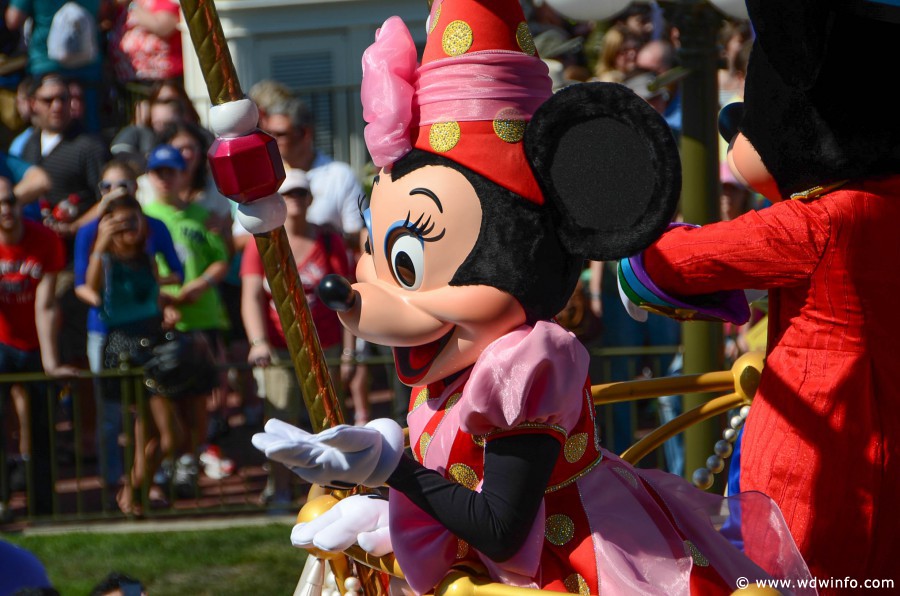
left=87, top=331, right=124, bottom=486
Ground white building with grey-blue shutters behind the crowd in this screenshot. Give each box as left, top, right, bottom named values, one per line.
left=184, top=0, right=428, bottom=172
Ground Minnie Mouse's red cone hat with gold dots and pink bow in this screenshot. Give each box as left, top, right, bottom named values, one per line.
left=362, top=0, right=552, bottom=204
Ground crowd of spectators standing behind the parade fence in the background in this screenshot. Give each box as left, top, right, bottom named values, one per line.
left=0, top=0, right=751, bottom=513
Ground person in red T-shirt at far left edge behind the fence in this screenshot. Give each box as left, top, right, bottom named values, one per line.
left=0, top=177, right=76, bottom=513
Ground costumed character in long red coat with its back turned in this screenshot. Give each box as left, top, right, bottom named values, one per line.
left=620, top=0, right=900, bottom=582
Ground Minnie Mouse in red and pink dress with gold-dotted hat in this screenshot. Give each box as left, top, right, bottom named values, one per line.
left=254, top=0, right=805, bottom=594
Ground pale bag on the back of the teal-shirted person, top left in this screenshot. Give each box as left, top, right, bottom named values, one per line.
left=47, top=2, right=99, bottom=68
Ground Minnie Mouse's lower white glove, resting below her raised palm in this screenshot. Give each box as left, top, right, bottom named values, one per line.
left=291, top=495, right=394, bottom=557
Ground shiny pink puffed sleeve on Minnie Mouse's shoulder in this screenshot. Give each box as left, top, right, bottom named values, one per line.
left=459, top=321, right=589, bottom=440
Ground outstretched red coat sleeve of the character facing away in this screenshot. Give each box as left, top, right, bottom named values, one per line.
left=644, top=199, right=831, bottom=296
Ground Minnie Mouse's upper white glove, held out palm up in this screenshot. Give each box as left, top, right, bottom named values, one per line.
left=252, top=418, right=403, bottom=488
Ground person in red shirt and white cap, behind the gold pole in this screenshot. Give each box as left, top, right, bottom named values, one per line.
left=241, top=169, right=355, bottom=504
